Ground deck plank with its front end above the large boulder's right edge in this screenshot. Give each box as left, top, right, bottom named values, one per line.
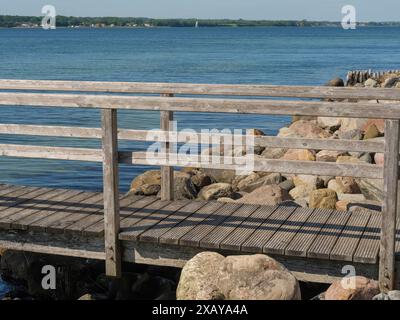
left=285, top=209, right=333, bottom=257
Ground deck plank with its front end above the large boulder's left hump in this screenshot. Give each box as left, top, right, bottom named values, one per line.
left=200, top=205, right=260, bottom=249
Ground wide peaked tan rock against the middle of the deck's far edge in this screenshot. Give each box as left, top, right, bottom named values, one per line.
left=236, top=185, right=292, bottom=205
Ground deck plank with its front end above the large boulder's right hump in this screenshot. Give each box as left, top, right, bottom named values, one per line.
left=241, top=206, right=296, bottom=253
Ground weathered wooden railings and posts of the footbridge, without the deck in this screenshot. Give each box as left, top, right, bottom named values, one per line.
left=0, top=80, right=400, bottom=291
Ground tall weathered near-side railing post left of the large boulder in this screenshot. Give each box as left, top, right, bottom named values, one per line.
left=102, top=109, right=121, bottom=277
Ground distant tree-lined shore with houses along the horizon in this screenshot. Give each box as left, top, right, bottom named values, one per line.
left=0, top=15, right=400, bottom=28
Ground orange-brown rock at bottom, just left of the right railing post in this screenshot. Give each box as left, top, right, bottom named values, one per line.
left=325, top=277, right=380, bottom=300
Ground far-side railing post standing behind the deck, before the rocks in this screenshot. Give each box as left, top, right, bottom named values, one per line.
left=160, top=94, right=174, bottom=201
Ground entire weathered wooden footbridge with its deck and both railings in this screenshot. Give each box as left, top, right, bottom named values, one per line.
left=0, top=80, right=400, bottom=291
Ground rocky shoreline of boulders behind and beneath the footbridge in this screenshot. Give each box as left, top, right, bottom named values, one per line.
left=0, top=72, right=400, bottom=300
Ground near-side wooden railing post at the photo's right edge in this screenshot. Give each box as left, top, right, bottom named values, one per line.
left=379, top=120, right=400, bottom=292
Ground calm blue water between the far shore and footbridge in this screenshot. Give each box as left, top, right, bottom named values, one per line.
left=0, top=28, right=400, bottom=192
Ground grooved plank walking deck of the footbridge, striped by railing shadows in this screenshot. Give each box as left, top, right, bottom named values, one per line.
left=0, top=185, right=400, bottom=272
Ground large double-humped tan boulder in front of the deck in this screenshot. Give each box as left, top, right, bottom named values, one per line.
left=177, top=252, right=301, bottom=300
